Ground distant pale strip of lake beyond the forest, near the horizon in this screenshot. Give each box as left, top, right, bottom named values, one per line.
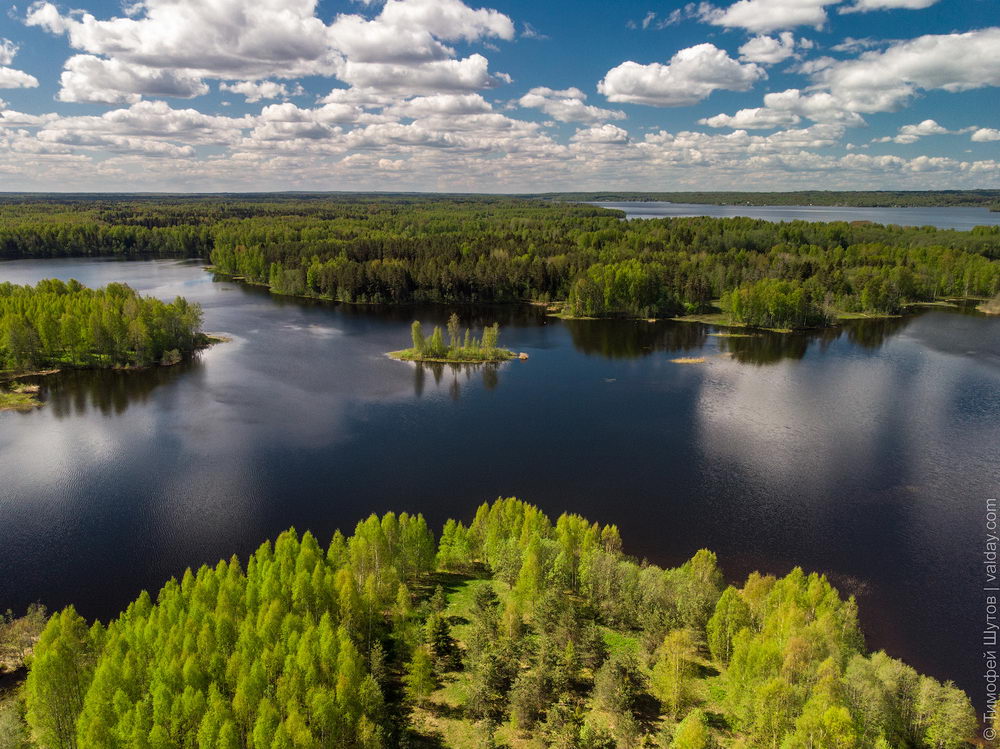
left=592, top=201, right=1000, bottom=230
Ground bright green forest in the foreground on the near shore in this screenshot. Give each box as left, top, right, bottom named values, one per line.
left=0, top=499, right=978, bottom=749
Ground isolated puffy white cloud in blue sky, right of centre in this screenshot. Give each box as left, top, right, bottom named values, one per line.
left=597, top=43, right=767, bottom=107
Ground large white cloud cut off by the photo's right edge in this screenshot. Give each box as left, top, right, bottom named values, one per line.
left=814, top=27, right=1000, bottom=112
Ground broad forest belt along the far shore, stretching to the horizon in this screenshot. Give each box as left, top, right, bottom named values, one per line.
left=0, top=195, right=1000, bottom=327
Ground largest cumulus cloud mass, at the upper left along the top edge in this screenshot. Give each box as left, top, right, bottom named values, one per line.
left=26, top=0, right=514, bottom=103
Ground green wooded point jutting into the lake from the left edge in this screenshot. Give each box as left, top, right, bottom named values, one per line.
left=0, top=279, right=206, bottom=373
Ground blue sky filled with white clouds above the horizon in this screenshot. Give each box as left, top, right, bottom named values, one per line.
left=0, top=0, right=1000, bottom=193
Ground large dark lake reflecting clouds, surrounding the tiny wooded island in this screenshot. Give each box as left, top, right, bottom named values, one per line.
left=0, top=259, right=1000, bottom=707
